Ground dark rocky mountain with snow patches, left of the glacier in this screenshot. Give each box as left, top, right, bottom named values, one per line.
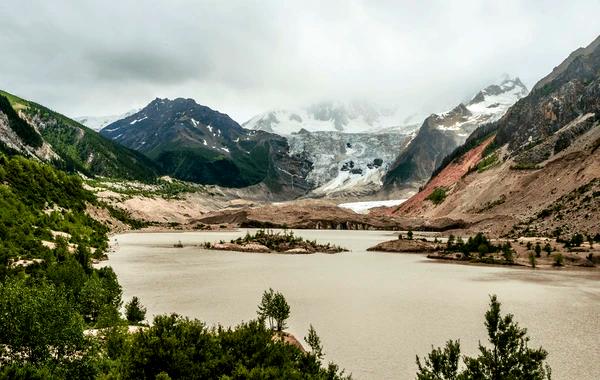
left=100, top=98, right=311, bottom=194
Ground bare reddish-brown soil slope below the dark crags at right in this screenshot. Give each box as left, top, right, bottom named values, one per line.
left=375, top=126, right=600, bottom=237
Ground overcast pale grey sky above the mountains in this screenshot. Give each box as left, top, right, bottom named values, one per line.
left=0, top=0, right=600, bottom=123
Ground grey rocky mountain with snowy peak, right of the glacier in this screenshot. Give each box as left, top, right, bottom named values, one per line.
left=384, top=77, right=527, bottom=191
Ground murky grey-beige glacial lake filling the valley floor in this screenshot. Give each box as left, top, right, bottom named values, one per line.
left=106, top=230, right=600, bottom=380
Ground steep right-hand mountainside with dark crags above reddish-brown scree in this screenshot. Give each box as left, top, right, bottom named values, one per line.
left=393, top=37, right=600, bottom=237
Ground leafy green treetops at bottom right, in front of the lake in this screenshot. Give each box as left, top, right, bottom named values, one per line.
left=417, top=296, right=551, bottom=380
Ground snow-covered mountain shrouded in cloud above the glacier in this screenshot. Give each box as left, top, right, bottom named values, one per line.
left=243, top=102, right=419, bottom=136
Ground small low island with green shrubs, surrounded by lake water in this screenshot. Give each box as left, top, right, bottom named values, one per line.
left=202, top=230, right=348, bottom=254
